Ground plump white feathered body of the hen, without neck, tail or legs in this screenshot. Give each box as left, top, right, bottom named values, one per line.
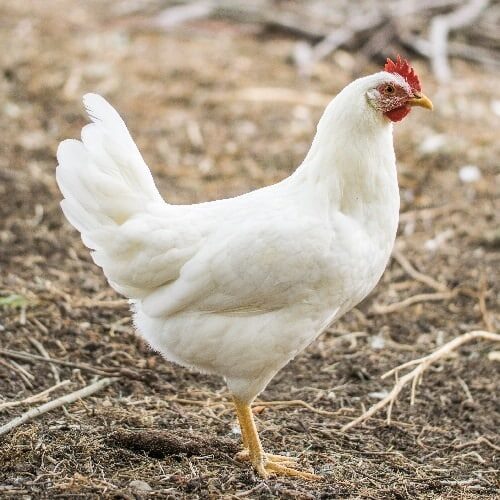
left=134, top=134, right=398, bottom=402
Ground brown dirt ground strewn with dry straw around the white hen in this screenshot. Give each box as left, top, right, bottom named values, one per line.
left=0, top=0, right=500, bottom=499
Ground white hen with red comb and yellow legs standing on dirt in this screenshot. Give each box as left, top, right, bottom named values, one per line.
left=57, top=56, right=432, bottom=479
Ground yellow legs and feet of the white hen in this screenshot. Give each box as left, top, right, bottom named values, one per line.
left=234, top=398, right=322, bottom=480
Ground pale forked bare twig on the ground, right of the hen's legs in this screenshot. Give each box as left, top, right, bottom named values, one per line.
left=341, top=330, right=500, bottom=431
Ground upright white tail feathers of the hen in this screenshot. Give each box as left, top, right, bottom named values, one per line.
left=56, top=94, right=163, bottom=233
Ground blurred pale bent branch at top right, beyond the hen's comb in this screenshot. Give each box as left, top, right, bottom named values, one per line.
left=429, top=0, right=489, bottom=82
